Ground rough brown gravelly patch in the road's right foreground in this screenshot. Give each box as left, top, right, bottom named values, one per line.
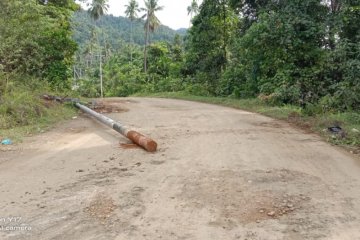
left=180, top=170, right=317, bottom=229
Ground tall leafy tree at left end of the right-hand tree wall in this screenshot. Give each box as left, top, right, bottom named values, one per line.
left=183, top=0, right=237, bottom=93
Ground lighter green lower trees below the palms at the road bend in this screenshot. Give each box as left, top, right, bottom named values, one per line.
left=74, top=32, right=183, bottom=97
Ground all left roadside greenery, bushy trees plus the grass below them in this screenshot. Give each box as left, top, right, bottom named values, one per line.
left=0, top=0, right=78, bottom=142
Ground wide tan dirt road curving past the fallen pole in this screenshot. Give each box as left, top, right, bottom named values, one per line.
left=0, top=98, right=360, bottom=240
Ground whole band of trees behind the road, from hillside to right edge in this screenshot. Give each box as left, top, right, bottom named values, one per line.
left=72, top=0, right=360, bottom=113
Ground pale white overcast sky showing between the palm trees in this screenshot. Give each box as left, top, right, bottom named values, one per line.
left=80, top=0, right=202, bottom=29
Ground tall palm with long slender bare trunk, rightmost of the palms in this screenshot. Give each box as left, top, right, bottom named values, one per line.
left=141, top=0, right=164, bottom=72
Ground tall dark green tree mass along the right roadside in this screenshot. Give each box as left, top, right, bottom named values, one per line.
left=185, top=0, right=360, bottom=109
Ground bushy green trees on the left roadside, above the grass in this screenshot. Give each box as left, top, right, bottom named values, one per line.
left=0, top=0, right=77, bottom=91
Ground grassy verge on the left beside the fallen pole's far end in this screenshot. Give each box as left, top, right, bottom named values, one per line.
left=0, top=80, right=77, bottom=143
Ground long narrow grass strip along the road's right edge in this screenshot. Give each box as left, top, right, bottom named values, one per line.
left=135, top=92, right=360, bottom=150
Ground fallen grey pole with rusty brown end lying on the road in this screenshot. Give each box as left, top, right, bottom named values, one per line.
left=75, top=102, right=157, bottom=152
